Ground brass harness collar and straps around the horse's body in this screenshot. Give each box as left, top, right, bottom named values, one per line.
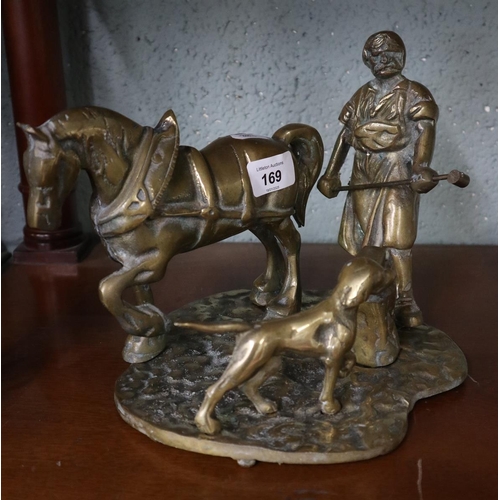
left=94, top=122, right=293, bottom=242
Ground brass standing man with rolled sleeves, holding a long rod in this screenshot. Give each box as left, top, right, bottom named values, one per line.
left=318, top=31, right=438, bottom=326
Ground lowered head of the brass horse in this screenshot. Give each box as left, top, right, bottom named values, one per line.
left=18, top=124, right=80, bottom=230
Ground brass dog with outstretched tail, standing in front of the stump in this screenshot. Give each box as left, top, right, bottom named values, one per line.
left=175, top=247, right=395, bottom=434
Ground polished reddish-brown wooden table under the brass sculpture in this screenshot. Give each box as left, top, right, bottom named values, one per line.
left=2, top=243, right=497, bottom=500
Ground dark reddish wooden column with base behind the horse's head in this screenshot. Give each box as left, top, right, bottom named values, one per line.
left=2, top=0, right=88, bottom=264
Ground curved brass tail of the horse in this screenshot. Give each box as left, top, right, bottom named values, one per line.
left=273, top=123, right=325, bottom=227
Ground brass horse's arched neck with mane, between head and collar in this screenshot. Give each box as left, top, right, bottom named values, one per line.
left=49, top=107, right=144, bottom=205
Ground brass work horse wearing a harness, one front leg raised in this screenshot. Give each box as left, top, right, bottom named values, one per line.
left=20, top=107, right=324, bottom=363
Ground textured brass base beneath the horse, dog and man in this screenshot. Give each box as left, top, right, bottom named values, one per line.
left=115, top=290, right=467, bottom=465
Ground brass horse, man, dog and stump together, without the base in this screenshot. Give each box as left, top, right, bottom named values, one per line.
left=21, top=31, right=468, bottom=442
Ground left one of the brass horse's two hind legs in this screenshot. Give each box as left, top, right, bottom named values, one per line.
left=250, top=226, right=285, bottom=307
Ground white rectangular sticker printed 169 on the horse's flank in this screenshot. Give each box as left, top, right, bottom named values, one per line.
left=247, top=151, right=295, bottom=197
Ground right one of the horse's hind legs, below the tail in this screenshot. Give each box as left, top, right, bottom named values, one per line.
left=266, top=217, right=302, bottom=318
